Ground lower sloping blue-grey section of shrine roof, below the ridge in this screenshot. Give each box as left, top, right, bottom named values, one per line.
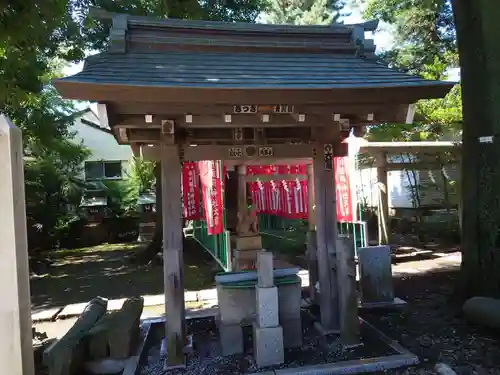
left=57, top=51, right=450, bottom=89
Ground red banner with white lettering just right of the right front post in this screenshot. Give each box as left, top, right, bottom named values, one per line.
left=334, top=157, right=354, bottom=222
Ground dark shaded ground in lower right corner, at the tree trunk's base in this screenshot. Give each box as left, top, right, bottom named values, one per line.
left=363, top=267, right=500, bottom=375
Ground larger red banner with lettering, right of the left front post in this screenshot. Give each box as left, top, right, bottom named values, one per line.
left=198, top=160, right=224, bottom=235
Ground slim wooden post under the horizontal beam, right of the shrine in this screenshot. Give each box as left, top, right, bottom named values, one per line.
left=376, top=152, right=390, bottom=245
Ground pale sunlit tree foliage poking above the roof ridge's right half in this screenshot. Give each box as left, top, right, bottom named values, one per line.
left=264, top=0, right=344, bottom=25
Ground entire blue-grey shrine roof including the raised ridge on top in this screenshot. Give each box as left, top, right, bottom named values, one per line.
left=55, top=15, right=451, bottom=94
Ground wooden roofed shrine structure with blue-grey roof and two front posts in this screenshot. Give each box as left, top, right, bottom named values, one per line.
left=54, top=13, right=453, bottom=368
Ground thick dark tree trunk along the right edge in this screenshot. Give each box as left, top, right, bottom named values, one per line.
left=453, top=0, right=500, bottom=297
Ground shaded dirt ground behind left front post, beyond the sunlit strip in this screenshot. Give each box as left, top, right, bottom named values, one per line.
left=31, top=240, right=218, bottom=310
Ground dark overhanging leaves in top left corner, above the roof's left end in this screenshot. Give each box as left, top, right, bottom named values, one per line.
left=0, top=0, right=266, bottom=108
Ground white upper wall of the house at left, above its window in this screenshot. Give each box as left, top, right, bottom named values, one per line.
left=71, top=111, right=133, bottom=176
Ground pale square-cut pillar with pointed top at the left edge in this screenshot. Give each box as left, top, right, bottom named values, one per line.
left=0, top=114, right=35, bottom=375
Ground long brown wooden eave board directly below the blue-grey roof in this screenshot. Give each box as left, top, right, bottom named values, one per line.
left=53, top=79, right=454, bottom=107
